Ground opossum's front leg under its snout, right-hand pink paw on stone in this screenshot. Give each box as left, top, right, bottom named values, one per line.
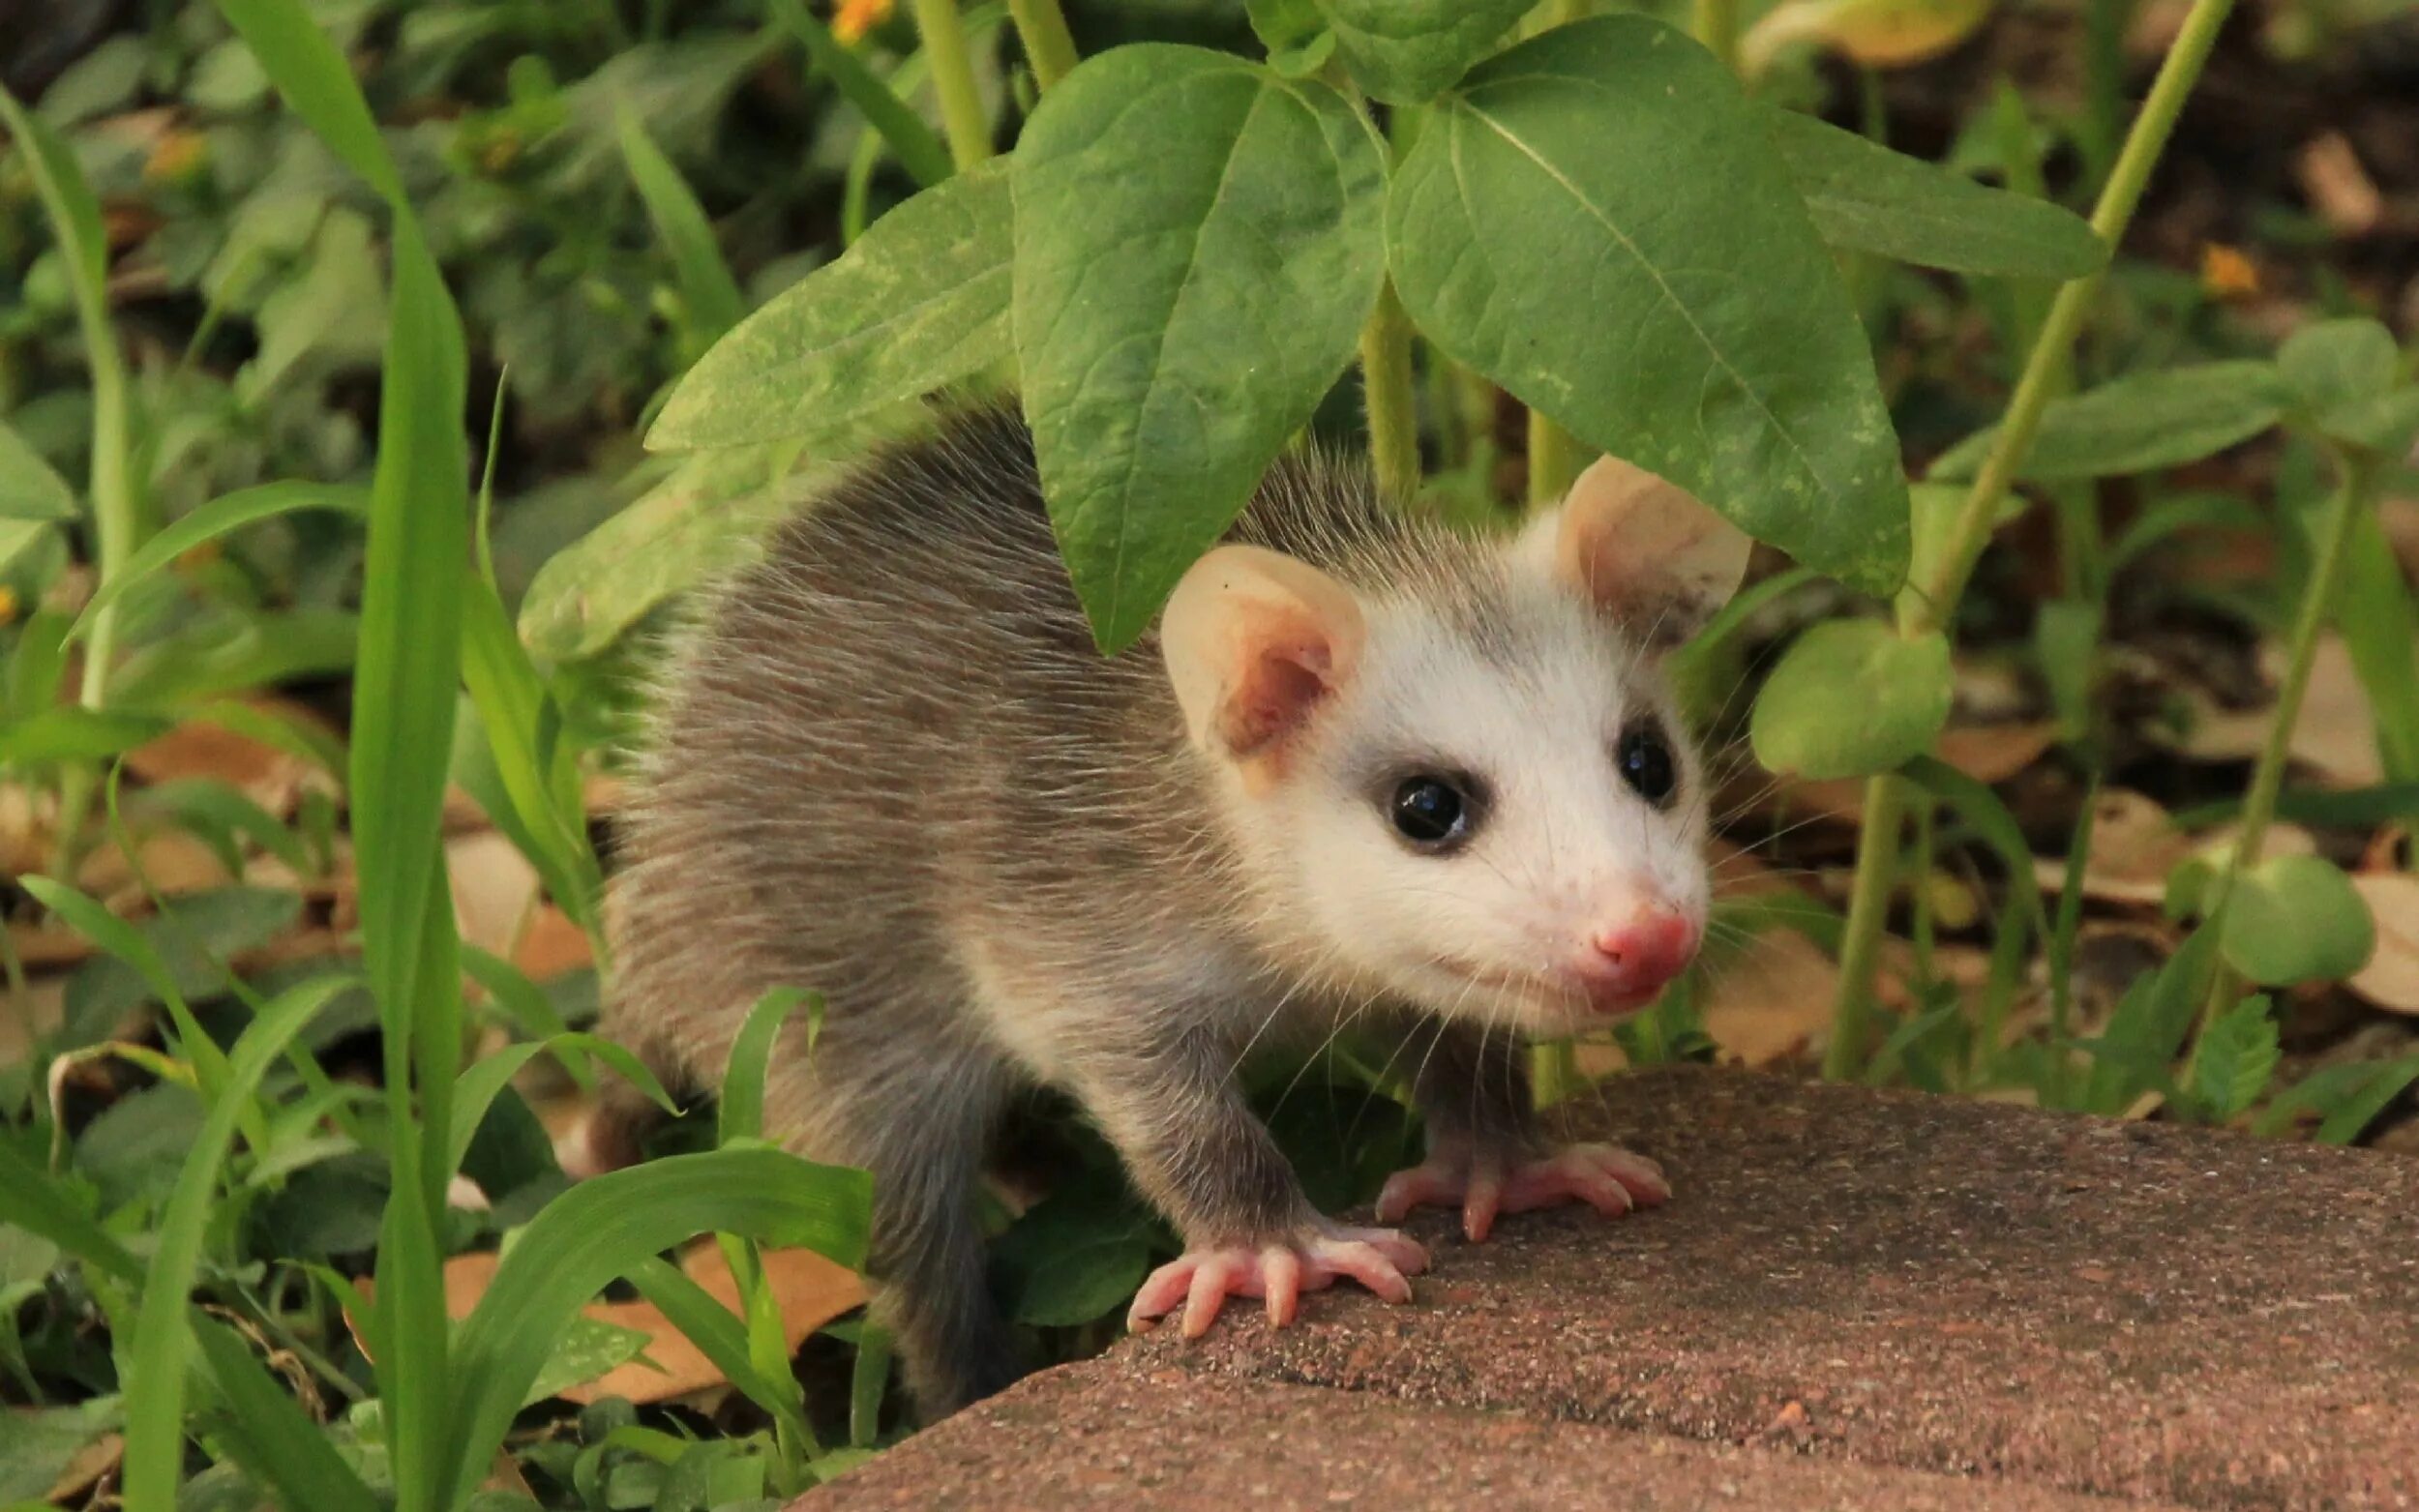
left=1377, top=1023, right=1672, bottom=1241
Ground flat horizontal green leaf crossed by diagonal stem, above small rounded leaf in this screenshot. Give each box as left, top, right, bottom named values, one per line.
left=1926, top=363, right=2286, bottom=484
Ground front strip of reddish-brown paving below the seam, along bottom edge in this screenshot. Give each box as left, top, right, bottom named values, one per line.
left=798, top=1359, right=2158, bottom=1512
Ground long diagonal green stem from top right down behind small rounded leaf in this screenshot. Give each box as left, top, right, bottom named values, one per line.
left=1819, top=0, right=2233, bottom=1082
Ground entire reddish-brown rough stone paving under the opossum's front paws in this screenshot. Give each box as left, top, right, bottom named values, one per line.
left=808, top=1069, right=2419, bottom=1507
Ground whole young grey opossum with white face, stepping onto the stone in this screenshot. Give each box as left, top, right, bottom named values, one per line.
left=598, top=411, right=1749, bottom=1417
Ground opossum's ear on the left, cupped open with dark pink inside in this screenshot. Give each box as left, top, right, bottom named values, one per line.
left=1159, top=547, right=1362, bottom=762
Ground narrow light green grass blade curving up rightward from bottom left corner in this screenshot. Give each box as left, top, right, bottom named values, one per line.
left=126, top=977, right=346, bottom=1512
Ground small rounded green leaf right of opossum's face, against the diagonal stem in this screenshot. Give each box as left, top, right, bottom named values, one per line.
left=1747, top=619, right=1950, bottom=782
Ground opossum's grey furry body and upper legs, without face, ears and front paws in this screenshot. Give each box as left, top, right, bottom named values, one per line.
left=605, top=411, right=1606, bottom=1415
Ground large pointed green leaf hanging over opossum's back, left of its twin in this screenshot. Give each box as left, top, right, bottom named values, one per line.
left=1014, top=44, right=1384, bottom=651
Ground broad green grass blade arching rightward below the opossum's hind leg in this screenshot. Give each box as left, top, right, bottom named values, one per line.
left=440, top=1149, right=874, bottom=1504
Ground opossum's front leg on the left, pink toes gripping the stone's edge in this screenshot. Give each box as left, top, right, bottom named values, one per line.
left=1074, top=1035, right=1427, bottom=1338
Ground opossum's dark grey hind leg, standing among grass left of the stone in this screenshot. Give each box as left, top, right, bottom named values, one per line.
left=793, top=1019, right=1024, bottom=1422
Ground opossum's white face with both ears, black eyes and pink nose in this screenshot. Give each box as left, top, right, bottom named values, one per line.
left=1161, top=460, right=1749, bottom=1033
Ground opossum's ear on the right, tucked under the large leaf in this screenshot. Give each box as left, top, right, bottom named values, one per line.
left=1522, top=458, right=1754, bottom=646
